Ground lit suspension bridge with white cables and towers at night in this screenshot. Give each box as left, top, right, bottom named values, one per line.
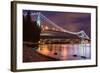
left=31, top=12, right=89, bottom=39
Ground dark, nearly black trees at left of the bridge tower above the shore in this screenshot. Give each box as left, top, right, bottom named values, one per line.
left=23, top=11, right=41, bottom=43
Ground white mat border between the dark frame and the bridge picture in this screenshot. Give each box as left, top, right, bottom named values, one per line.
left=17, top=4, right=96, bottom=69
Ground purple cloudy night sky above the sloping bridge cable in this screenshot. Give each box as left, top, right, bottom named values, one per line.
left=23, top=10, right=91, bottom=37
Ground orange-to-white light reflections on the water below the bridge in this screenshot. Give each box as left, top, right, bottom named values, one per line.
left=37, top=44, right=91, bottom=60
